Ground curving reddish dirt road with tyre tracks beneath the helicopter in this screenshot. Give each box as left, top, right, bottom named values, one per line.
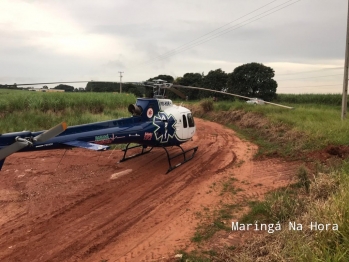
left=0, top=119, right=300, bottom=262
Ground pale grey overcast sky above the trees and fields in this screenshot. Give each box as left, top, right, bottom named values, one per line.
left=0, top=0, right=348, bottom=93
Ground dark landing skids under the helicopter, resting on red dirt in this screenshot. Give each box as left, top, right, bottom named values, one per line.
left=119, top=144, right=198, bottom=174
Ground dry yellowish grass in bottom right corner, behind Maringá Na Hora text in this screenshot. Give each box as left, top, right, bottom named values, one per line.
left=216, top=162, right=349, bottom=261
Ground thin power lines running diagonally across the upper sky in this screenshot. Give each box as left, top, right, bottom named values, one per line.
left=141, top=0, right=300, bottom=63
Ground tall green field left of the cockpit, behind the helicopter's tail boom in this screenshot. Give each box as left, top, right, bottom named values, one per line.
left=0, top=89, right=136, bottom=133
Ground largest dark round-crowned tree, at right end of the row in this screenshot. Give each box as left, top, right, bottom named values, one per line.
left=227, top=63, right=277, bottom=101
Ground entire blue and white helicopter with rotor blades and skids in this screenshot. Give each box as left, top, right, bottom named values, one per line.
left=0, top=79, right=292, bottom=174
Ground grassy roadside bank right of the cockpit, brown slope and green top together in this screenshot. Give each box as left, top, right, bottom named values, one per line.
left=188, top=101, right=349, bottom=157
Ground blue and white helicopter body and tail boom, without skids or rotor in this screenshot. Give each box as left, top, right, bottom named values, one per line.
left=0, top=98, right=196, bottom=154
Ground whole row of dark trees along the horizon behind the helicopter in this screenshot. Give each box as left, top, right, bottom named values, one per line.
left=0, top=63, right=277, bottom=101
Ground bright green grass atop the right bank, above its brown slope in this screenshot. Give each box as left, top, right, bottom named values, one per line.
left=214, top=101, right=349, bottom=149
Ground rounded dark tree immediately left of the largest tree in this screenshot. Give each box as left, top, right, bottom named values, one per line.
left=200, top=68, right=228, bottom=98
